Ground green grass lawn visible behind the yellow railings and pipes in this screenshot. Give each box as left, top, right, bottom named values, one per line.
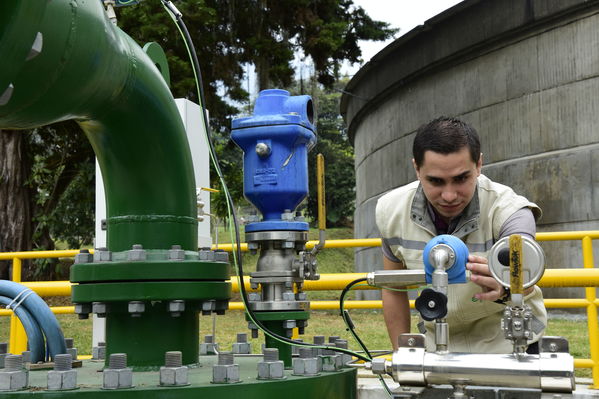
left=0, top=228, right=591, bottom=377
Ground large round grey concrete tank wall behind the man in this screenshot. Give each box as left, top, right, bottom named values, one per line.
left=341, top=0, right=599, bottom=298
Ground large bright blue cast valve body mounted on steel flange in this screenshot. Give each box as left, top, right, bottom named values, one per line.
left=231, top=89, right=316, bottom=232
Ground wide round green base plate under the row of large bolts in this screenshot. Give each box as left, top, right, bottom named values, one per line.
left=0, top=356, right=357, bottom=399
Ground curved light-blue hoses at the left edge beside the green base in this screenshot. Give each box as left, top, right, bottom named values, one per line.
left=0, top=280, right=67, bottom=362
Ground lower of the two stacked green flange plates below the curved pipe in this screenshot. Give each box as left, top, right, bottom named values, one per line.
left=72, top=281, right=231, bottom=303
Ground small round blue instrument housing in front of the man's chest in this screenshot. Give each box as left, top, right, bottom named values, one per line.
left=422, top=234, right=468, bottom=284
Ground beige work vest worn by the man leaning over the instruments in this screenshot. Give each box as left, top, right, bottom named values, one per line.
left=376, top=175, right=547, bottom=353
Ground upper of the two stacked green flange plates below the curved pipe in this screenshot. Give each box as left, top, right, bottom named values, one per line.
left=71, top=260, right=230, bottom=283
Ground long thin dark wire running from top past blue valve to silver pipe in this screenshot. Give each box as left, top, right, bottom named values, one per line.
left=161, top=0, right=370, bottom=361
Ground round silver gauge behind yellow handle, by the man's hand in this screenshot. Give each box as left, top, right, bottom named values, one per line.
left=489, top=236, right=545, bottom=288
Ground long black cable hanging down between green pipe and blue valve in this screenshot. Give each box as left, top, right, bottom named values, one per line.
left=161, top=0, right=370, bottom=361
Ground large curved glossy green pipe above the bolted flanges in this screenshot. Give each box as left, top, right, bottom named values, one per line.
left=0, top=0, right=197, bottom=251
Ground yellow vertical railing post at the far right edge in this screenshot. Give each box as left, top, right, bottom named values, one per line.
left=582, top=236, right=599, bottom=389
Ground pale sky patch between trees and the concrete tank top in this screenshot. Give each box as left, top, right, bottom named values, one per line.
left=342, top=0, right=460, bottom=76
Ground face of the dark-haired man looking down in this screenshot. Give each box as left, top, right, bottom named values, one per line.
left=412, top=147, right=482, bottom=222
